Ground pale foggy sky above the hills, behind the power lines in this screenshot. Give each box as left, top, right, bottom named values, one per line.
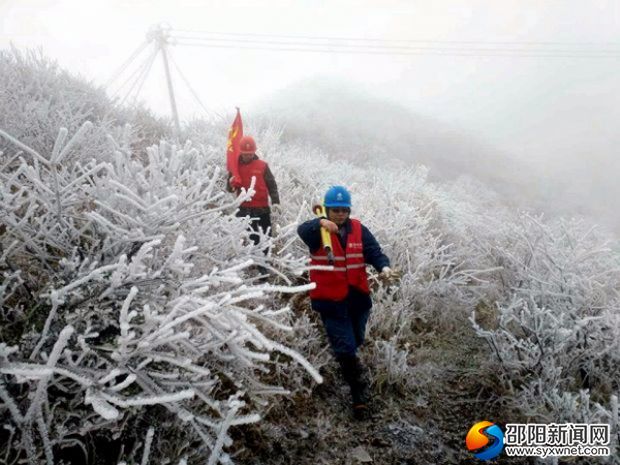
left=0, top=0, right=620, bottom=231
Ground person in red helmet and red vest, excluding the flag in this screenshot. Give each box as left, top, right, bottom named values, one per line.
left=228, top=136, right=280, bottom=244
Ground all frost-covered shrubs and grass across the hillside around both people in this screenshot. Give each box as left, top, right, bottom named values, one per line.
left=0, top=51, right=620, bottom=463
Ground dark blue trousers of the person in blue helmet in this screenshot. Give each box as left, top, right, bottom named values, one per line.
left=319, top=298, right=370, bottom=358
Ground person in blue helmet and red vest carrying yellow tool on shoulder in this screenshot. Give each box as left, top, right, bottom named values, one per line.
left=297, top=186, right=393, bottom=419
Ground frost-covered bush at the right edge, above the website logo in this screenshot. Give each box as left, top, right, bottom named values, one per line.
left=471, top=215, right=620, bottom=421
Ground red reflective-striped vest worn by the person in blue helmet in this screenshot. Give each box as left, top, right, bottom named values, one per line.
left=310, top=219, right=370, bottom=301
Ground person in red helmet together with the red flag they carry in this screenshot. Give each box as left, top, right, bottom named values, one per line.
left=226, top=108, right=280, bottom=246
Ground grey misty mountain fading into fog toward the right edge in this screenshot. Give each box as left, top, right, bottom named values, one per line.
left=256, top=78, right=620, bottom=231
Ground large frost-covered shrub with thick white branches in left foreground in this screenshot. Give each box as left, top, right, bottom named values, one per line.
left=0, top=123, right=321, bottom=463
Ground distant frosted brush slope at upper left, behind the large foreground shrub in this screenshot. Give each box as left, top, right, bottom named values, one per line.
left=0, top=48, right=170, bottom=165
